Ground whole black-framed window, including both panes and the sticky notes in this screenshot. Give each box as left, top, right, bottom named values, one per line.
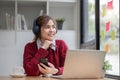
left=80, top=0, right=120, bottom=77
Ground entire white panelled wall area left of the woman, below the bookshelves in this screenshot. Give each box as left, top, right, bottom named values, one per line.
left=0, top=31, right=33, bottom=76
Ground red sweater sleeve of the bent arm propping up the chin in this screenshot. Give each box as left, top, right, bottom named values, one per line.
left=23, top=43, right=48, bottom=76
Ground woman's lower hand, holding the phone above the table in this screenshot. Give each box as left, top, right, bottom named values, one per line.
left=38, top=62, right=58, bottom=74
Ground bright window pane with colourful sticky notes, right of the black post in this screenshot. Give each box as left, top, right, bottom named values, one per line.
left=100, top=0, right=120, bottom=76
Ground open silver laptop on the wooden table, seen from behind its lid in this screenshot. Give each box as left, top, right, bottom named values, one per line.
left=52, top=50, right=105, bottom=79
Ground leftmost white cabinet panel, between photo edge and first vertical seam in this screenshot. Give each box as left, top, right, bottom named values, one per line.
left=0, top=31, right=17, bottom=75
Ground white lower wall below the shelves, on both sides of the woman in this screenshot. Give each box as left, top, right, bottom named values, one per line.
left=0, top=30, right=77, bottom=76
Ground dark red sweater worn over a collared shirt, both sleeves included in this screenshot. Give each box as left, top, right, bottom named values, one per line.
left=23, top=40, right=68, bottom=76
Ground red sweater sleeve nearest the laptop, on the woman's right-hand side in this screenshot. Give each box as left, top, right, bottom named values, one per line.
left=57, top=40, right=68, bottom=75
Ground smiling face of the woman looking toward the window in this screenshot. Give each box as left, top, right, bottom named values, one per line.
left=41, top=20, right=56, bottom=41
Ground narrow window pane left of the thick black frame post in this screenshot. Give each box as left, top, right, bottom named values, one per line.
left=80, top=0, right=96, bottom=49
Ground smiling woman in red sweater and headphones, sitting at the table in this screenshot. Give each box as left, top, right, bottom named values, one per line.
left=23, top=15, right=68, bottom=76
